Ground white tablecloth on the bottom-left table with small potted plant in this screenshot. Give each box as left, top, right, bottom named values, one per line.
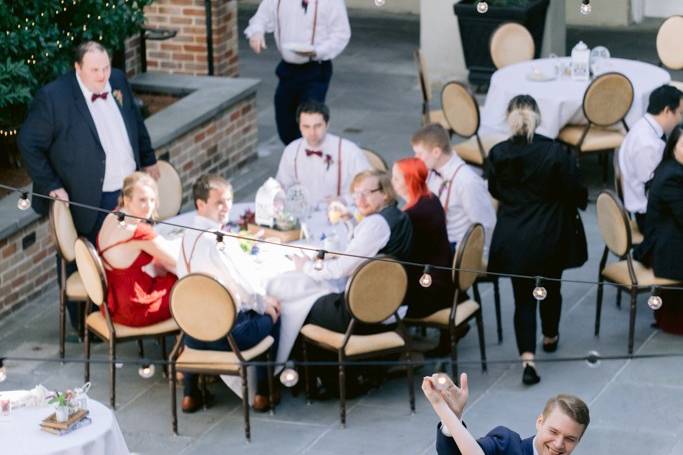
left=0, top=400, right=129, bottom=455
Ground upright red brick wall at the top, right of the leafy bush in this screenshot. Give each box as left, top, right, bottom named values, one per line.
left=126, top=0, right=239, bottom=77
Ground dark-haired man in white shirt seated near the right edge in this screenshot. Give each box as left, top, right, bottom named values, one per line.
left=619, top=85, right=683, bottom=232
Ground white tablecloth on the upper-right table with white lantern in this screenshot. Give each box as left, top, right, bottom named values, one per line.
left=481, top=57, right=671, bottom=138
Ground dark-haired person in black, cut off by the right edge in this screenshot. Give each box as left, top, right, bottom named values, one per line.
left=635, top=126, right=683, bottom=335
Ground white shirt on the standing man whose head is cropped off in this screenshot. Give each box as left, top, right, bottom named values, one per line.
left=244, top=0, right=351, bottom=64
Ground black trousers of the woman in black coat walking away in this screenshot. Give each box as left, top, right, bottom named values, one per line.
left=510, top=272, right=562, bottom=354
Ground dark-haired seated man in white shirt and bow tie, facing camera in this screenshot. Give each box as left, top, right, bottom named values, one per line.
left=276, top=101, right=371, bottom=205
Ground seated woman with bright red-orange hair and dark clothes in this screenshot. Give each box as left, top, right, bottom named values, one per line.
left=391, top=158, right=454, bottom=318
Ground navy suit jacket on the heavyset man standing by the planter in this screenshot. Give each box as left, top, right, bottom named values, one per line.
left=17, top=69, right=156, bottom=234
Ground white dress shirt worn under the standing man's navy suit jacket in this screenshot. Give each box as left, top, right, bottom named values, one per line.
left=76, top=74, right=137, bottom=191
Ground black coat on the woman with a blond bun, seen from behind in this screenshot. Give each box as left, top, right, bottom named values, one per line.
left=486, top=135, right=588, bottom=275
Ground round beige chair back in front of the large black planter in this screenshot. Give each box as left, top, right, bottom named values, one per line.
left=489, top=22, right=536, bottom=68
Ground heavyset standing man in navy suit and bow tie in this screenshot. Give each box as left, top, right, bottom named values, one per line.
left=17, top=41, right=159, bottom=334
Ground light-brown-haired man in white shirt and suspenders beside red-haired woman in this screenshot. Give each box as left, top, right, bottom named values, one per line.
left=410, top=123, right=496, bottom=252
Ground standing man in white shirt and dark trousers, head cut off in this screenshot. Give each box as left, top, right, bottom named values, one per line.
left=244, top=0, right=351, bottom=145
